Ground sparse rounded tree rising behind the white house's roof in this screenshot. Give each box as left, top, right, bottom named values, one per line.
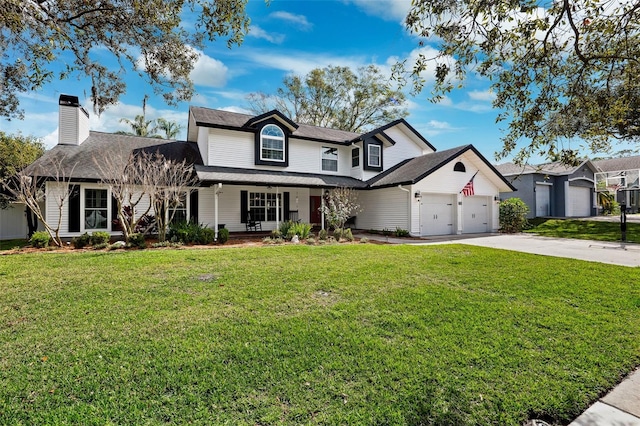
left=247, top=65, right=409, bottom=132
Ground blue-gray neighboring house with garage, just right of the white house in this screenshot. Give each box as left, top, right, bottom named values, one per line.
left=496, top=160, right=597, bottom=218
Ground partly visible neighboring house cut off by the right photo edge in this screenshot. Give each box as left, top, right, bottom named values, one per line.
left=593, top=155, right=640, bottom=213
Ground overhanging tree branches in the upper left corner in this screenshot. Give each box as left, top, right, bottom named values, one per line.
left=0, top=0, right=249, bottom=118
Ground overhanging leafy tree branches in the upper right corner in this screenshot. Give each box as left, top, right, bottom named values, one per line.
left=402, top=0, right=640, bottom=162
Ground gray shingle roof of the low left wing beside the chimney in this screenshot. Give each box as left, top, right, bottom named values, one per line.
left=25, top=132, right=202, bottom=181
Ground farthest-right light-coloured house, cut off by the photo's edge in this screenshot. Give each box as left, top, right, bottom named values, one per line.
left=593, top=155, right=640, bottom=213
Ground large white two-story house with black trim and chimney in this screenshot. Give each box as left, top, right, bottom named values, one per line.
left=15, top=95, right=515, bottom=237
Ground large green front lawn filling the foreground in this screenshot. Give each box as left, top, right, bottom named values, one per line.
left=0, top=244, right=640, bottom=425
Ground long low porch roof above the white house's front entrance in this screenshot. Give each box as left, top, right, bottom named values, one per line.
left=195, top=165, right=367, bottom=189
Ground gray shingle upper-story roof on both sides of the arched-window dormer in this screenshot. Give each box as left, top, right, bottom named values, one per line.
left=190, top=107, right=360, bottom=145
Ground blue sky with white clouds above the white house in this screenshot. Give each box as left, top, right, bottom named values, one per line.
left=0, top=0, right=556, bottom=163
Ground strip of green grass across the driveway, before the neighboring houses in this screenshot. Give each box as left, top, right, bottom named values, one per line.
left=525, top=219, right=640, bottom=243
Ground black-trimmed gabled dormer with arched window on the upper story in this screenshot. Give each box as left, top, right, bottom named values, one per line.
left=243, top=110, right=298, bottom=167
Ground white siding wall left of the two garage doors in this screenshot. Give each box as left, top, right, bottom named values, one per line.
left=356, top=187, right=410, bottom=231
